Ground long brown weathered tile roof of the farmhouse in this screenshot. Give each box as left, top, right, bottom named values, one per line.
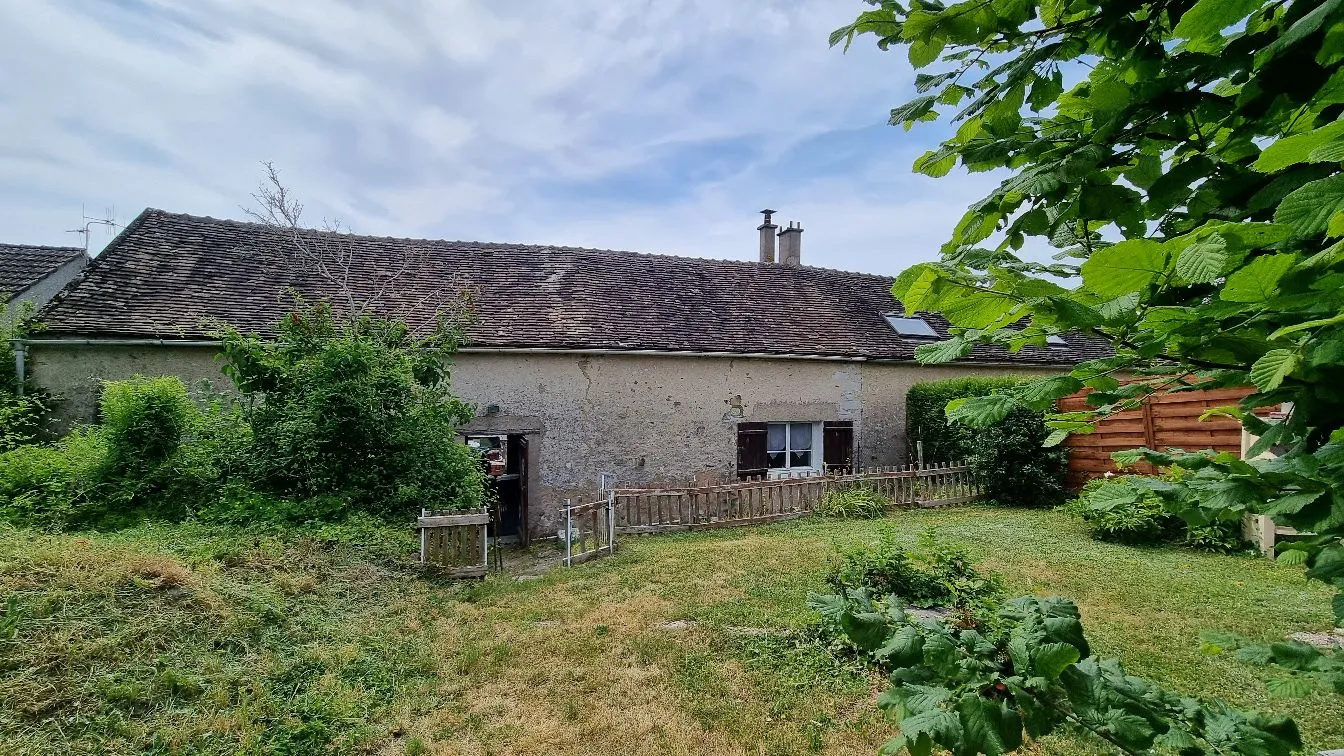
left=40, top=210, right=1106, bottom=365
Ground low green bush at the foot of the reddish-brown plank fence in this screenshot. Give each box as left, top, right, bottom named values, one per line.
left=1064, top=476, right=1245, bottom=553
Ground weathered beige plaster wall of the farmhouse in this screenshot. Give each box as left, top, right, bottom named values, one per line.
left=21, top=347, right=1040, bottom=534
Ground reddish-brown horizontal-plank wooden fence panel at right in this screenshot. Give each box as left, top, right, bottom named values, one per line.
left=1059, top=387, right=1254, bottom=490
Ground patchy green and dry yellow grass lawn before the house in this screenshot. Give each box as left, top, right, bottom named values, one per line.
left=0, top=507, right=1344, bottom=755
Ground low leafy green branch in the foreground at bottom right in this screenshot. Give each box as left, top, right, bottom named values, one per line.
left=821, top=591, right=1302, bottom=756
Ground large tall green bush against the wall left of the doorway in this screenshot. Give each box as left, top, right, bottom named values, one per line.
left=220, top=304, right=485, bottom=517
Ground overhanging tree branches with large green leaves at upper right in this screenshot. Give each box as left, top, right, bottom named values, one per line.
left=832, top=0, right=1344, bottom=621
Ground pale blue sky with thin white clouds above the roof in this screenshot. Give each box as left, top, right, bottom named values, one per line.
left=0, top=0, right=1010, bottom=274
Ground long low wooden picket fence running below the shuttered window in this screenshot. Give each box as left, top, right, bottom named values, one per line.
left=610, top=461, right=984, bottom=534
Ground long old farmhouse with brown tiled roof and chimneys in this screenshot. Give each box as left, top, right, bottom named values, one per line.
left=20, top=203, right=1105, bottom=541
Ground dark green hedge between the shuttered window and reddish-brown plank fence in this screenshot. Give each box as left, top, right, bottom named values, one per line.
left=906, top=378, right=1068, bottom=507
